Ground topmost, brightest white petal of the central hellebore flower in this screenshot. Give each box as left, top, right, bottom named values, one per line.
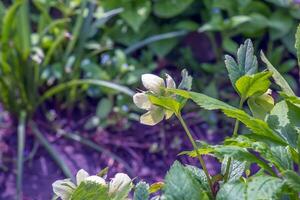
left=142, top=74, right=165, bottom=94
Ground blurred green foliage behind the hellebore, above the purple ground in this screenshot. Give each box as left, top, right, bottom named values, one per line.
left=0, top=0, right=300, bottom=198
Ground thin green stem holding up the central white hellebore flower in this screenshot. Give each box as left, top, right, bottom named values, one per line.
left=176, top=113, right=213, bottom=194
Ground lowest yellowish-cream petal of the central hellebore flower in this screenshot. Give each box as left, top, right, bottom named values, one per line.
left=140, top=107, right=164, bottom=126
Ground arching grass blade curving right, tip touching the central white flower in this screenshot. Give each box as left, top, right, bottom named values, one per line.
left=37, top=79, right=134, bottom=105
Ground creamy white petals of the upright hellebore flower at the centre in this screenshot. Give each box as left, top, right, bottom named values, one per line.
left=133, top=74, right=176, bottom=126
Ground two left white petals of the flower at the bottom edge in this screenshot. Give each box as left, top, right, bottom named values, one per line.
left=52, top=169, right=106, bottom=200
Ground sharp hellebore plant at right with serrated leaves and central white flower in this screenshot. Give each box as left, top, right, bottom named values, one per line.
left=54, top=34, right=300, bottom=200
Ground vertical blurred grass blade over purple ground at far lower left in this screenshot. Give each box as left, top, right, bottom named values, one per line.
left=17, top=111, right=26, bottom=200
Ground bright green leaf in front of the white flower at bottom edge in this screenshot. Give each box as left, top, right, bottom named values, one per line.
left=71, top=181, right=109, bottom=200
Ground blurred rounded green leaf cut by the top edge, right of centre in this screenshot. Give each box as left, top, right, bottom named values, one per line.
left=153, top=0, right=194, bottom=18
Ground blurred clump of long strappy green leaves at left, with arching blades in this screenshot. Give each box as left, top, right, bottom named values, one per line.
left=0, top=0, right=133, bottom=199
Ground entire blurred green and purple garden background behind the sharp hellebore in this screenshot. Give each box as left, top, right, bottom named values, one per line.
left=0, top=0, right=300, bottom=200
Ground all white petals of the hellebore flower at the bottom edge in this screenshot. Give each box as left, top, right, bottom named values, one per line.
left=52, top=169, right=132, bottom=200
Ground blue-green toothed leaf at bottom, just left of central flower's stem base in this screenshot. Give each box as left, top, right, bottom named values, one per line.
left=164, top=161, right=208, bottom=200
